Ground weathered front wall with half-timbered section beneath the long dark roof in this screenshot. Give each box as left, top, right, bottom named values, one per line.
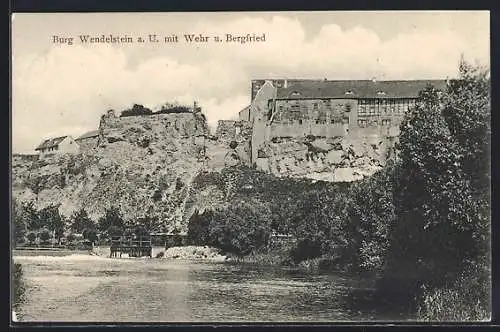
left=269, top=99, right=415, bottom=138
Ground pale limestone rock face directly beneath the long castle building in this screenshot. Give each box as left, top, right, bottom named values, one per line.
left=256, top=137, right=394, bottom=182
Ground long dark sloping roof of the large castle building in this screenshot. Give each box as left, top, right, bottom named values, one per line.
left=276, top=80, right=446, bottom=99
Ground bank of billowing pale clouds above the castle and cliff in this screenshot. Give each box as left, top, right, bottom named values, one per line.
left=12, top=15, right=489, bottom=151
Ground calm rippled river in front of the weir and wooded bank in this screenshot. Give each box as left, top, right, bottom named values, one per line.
left=14, top=250, right=414, bottom=323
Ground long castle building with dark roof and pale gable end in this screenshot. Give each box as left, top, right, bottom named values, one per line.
left=246, top=79, right=447, bottom=166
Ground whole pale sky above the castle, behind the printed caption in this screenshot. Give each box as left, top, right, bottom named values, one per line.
left=12, top=11, right=490, bottom=153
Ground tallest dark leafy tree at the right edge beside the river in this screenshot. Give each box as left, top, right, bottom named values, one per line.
left=389, top=63, right=490, bottom=296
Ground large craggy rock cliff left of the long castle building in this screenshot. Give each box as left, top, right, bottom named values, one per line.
left=12, top=111, right=244, bottom=231
